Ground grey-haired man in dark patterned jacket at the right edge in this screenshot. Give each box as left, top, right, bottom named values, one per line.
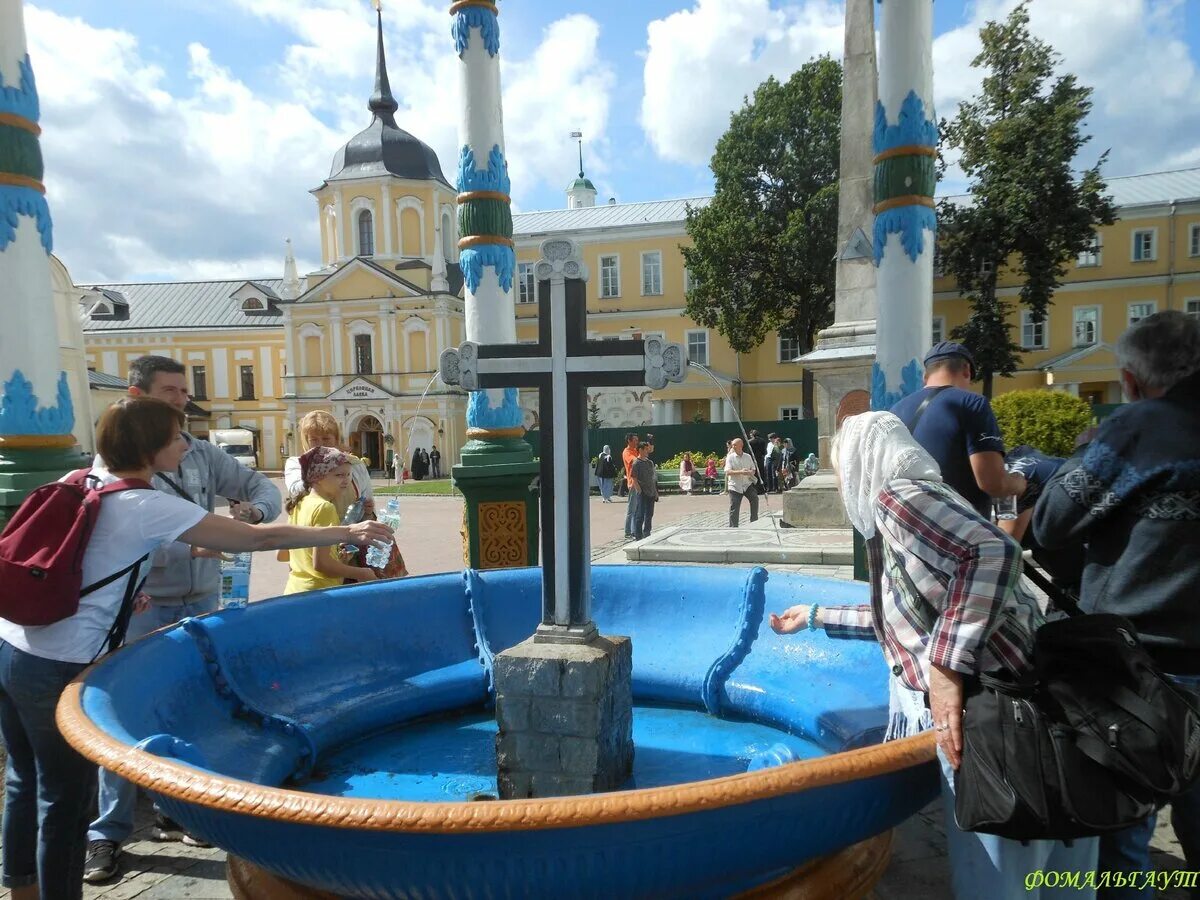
left=1033, top=311, right=1200, bottom=896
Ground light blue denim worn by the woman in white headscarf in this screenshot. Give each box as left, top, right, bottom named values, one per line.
left=937, top=750, right=1098, bottom=900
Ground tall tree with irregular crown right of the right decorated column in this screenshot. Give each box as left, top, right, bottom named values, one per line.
left=937, top=0, right=1116, bottom=397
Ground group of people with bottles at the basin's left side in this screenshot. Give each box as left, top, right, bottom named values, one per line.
left=0, top=356, right=394, bottom=900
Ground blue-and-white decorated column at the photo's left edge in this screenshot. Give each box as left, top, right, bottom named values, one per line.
left=0, top=0, right=82, bottom=522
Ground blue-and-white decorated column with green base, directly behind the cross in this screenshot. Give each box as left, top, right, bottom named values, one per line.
left=450, top=0, right=538, bottom=569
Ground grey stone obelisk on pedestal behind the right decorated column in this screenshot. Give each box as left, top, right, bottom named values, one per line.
left=784, top=0, right=878, bottom=528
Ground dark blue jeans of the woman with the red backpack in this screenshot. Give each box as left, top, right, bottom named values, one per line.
left=0, top=641, right=96, bottom=900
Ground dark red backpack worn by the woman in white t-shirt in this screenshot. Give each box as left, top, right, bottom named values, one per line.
left=0, top=469, right=154, bottom=625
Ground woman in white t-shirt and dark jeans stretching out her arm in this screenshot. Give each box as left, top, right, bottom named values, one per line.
left=0, top=397, right=391, bottom=900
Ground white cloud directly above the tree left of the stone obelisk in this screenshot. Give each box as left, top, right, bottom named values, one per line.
left=641, top=0, right=842, bottom=164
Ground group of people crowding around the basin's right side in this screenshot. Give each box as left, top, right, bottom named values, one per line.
left=772, top=311, right=1200, bottom=900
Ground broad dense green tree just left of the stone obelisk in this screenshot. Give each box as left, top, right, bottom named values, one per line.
left=683, top=56, right=841, bottom=353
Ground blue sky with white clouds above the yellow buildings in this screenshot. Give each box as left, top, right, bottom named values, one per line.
left=18, top=0, right=1200, bottom=283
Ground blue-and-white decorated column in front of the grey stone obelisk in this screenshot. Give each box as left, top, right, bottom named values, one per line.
left=871, top=0, right=937, bottom=409
